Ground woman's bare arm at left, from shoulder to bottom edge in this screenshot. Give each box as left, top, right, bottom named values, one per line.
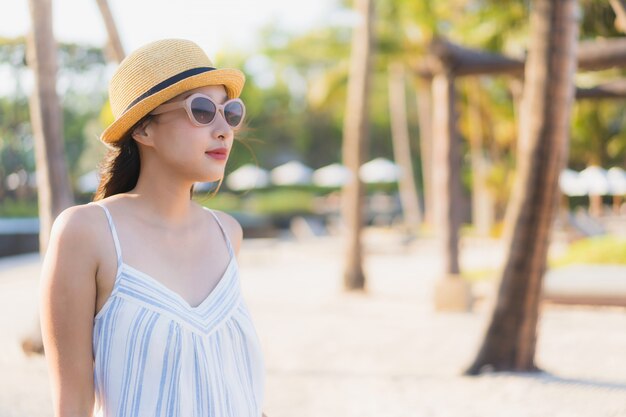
left=39, top=206, right=98, bottom=417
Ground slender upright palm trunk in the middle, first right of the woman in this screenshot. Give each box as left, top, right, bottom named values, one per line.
left=342, top=0, right=374, bottom=290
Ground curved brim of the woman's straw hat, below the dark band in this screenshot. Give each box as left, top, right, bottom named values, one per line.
left=100, top=68, right=245, bottom=145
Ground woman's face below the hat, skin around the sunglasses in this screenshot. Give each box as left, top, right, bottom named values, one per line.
left=140, top=85, right=234, bottom=182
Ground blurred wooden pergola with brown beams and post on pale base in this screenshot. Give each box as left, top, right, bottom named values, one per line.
left=414, top=38, right=626, bottom=310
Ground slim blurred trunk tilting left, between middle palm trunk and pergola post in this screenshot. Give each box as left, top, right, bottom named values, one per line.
left=388, top=63, right=422, bottom=235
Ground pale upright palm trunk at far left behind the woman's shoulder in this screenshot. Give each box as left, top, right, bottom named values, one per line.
left=22, top=0, right=74, bottom=353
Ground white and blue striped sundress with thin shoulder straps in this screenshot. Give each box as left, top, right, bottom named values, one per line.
left=92, top=202, right=264, bottom=417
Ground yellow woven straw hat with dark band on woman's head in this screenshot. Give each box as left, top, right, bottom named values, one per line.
left=100, top=39, right=245, bottom=145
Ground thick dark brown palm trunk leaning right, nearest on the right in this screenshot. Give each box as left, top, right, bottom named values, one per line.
left=467, top=0, right=578, bottom=374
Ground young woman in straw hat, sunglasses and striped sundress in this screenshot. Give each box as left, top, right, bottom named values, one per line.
left=40, top=39, right=264, bottom=417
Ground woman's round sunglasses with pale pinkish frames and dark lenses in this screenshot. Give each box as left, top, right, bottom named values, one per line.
left=150, top=93, right=246, bottom=129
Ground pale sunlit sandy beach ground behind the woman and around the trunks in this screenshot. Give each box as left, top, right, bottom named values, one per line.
left=0, top=229, right=626, bottom=417
